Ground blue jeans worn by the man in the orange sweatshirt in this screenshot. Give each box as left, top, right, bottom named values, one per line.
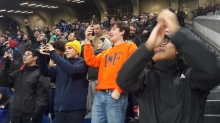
left=92, top=91, right=128, bottom=123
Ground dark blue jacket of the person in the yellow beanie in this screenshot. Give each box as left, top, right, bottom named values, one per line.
left=38, top=51, right=88, bottom=111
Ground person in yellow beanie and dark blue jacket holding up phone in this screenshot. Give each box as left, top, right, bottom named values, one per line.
left=38, top=41, right=88, bottom=123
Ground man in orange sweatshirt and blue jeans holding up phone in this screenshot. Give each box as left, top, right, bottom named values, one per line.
left=84, top=21, right=137, bottom=123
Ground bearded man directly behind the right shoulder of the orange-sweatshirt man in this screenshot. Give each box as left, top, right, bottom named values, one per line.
left=126, top=24, right=142, bottom=47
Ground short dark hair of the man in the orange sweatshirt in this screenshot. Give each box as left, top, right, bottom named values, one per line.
left=112, top=21, right=130, bottom=40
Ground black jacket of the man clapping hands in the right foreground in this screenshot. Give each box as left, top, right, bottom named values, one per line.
left=117, top=29, right=220, bottom=123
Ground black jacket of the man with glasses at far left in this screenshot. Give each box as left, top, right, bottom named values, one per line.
left=0, top=66, right=50, bottom=116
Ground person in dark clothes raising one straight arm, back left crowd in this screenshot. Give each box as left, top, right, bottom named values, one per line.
left=24, top=19, right=46, bottom=50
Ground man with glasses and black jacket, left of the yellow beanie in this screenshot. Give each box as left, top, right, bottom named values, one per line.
left=0, top=49, right=49, bottom=123
